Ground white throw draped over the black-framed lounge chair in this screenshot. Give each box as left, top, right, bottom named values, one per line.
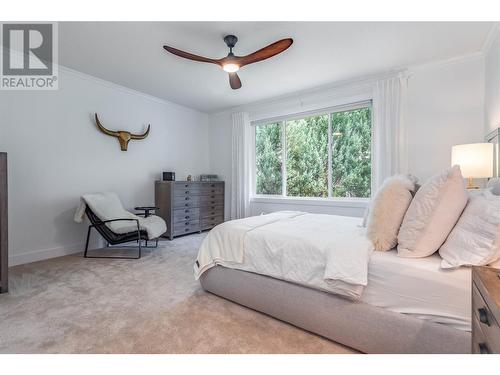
left=74, top=192, right=167, bottom=239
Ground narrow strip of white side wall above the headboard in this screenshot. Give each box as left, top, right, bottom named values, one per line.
left=485, top=28, right=500, bottom=133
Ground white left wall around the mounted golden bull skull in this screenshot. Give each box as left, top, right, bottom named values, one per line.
left=0, top=68, right=209, bottom=265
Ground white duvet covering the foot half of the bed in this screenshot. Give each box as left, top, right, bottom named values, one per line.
left=195, top=211, right=373, bottom=299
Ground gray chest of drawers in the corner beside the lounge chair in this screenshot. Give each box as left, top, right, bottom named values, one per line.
left=155, top=181, right=224, bottom=239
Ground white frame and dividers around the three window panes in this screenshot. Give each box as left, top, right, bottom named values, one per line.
left=251, top=99, right=373, bottom=203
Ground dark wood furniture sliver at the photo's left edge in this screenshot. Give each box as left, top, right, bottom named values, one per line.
left=0, top=152, right=9, bottom=293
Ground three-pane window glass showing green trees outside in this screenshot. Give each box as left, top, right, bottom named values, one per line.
left=255, top=104, right=371, bottom=198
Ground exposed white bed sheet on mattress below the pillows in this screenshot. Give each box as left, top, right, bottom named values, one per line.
left=361, top=250, right=471, bottom=331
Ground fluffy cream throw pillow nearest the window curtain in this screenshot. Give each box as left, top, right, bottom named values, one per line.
left=366, top=175, right=415, bottom=251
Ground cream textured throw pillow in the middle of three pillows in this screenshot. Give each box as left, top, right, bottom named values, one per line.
left=398, top=165, right=467, bottom=258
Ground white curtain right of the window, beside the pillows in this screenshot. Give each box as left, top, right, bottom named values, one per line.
left=371, top=75, right=408, bottom=195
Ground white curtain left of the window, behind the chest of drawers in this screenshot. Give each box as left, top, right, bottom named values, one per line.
left=231, top=112, right=254, bottom=219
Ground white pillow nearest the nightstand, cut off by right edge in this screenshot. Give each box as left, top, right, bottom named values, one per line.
left=439, top=190, right=500, bottom=268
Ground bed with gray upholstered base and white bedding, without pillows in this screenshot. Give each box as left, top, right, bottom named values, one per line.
left=195, top=212, right=471, bottom=353
